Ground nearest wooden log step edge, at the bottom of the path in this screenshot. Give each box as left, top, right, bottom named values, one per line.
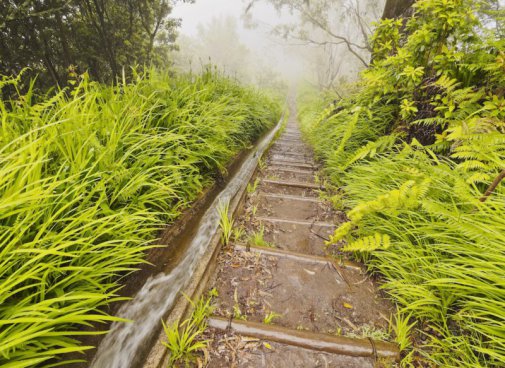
left=208, top=316, right=400, bottom=361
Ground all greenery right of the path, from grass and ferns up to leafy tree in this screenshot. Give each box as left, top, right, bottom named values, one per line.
left=300, top=0, right=505, bottom=367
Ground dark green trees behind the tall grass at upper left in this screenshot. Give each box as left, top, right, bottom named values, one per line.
left=0, top=0, right=187, bottom=88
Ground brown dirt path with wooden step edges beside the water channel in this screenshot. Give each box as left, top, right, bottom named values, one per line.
left=201, top=104, right=398, bottom=368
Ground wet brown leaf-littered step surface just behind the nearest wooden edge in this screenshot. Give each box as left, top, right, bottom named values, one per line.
left=214, top=251, right=390, bottom=336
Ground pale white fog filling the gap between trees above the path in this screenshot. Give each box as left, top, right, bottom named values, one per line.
left=173, top=0, right=385, bottom=88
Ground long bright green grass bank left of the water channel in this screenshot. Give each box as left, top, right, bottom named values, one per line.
left=0, top=71, right=279, bottom=368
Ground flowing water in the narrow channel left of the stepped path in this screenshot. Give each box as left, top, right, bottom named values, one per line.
left=90, top=118, right=280, bottom=368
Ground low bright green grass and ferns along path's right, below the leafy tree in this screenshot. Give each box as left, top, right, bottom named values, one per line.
left=301, top=94, right=505, bottom=368
